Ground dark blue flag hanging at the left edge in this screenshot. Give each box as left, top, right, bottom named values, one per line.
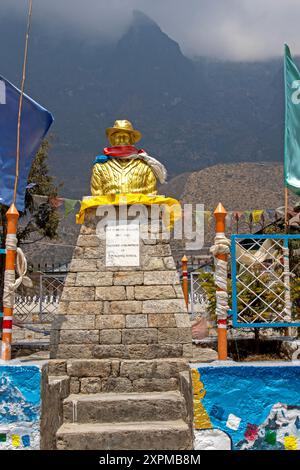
left=0, top=76, right=53, bottom=211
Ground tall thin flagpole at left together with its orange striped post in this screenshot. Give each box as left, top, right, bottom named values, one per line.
left=1, top=0, right=32, bottom=361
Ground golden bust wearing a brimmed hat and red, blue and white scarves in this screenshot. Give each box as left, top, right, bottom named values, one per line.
left=91, top=120, right=167, bottom=196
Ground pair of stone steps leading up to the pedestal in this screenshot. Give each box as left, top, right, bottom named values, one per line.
left=56, top=391, right=191, bottom=450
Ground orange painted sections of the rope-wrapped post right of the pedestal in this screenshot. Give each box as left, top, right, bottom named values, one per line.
left=214, top=203, right=227, bottom=361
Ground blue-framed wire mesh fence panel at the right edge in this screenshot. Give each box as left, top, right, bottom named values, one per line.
left=231, top=235, right=300, bottom=328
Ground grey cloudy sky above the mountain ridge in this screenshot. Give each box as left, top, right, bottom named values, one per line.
left=0, top=0, right=300, bottom=61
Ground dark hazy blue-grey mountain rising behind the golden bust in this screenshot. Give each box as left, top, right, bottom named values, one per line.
left=0, top=12, right=292, bottom=198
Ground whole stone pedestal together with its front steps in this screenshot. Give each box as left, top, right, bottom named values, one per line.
left=49, top=206, right=193, bottom=450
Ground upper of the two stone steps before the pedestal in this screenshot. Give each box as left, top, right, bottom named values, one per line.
left=63, top=391, right=186, bottom=423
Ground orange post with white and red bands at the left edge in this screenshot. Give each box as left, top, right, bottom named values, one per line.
left=1, top=204, right=19, bottom=361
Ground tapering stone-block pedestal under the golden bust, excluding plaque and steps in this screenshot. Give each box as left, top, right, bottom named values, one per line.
left=51, top=209, right=192, bottom=359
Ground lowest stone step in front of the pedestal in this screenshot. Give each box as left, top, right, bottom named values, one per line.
left=56, top=420, right=191, bottom=450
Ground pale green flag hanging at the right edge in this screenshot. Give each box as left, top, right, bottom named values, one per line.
left=284, top=44, right=300, bottom=196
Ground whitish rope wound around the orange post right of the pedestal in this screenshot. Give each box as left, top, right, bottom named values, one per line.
left=210, top=233, right=230, bottom=320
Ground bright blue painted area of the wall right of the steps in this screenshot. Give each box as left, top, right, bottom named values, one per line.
left=198, top=366, right=300, bottom=444
